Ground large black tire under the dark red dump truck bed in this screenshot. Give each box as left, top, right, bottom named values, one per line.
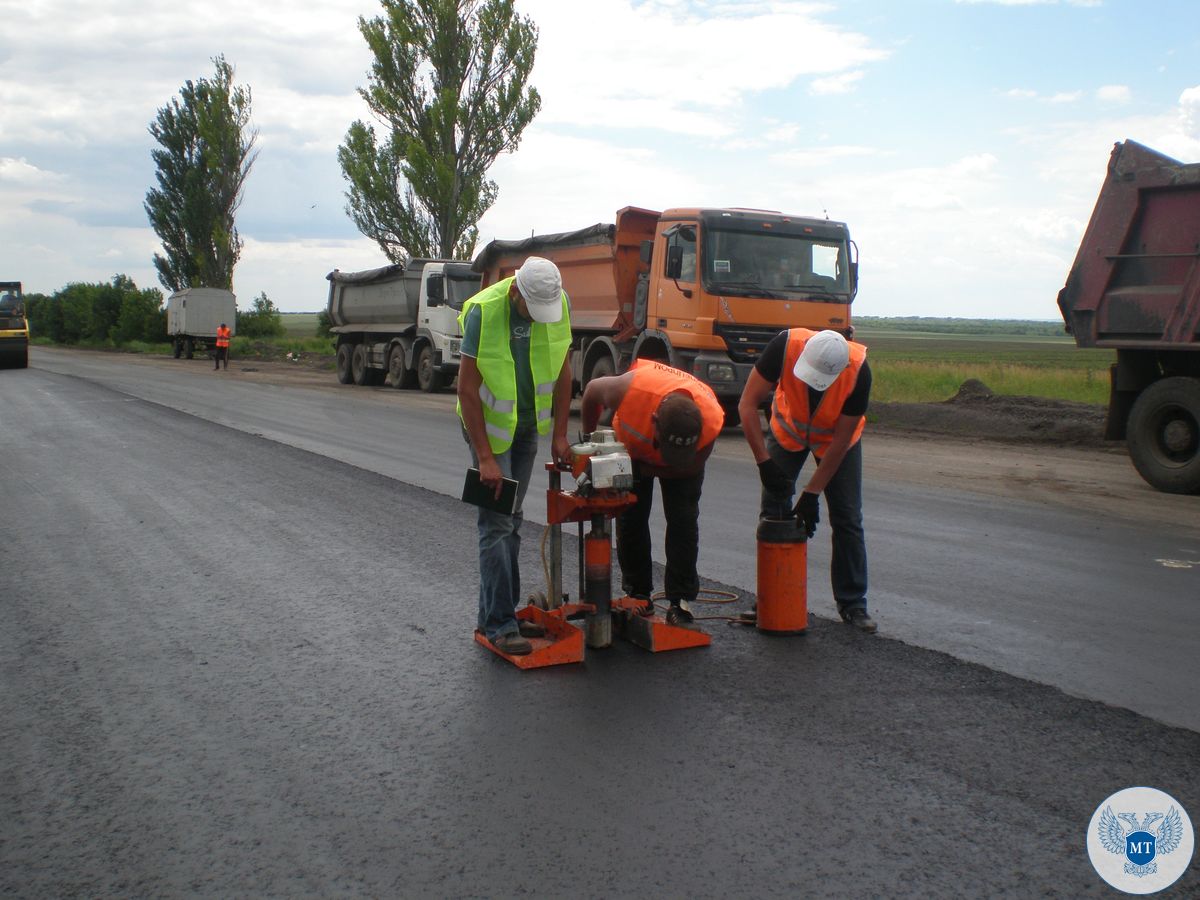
left=1126, top=377, right=1200, bottom=493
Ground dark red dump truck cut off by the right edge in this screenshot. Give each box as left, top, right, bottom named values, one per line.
left=1058, top=140, right=1200, bottom=493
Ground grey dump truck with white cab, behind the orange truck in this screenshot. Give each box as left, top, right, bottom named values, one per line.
left=325, top=259, right=480, bottom=391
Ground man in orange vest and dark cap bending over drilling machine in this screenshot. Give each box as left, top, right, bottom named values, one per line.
left=580, top=359, right=725, bottom=628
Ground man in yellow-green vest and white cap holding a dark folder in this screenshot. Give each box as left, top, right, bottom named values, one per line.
left=458, top=257, right=571, bottom=655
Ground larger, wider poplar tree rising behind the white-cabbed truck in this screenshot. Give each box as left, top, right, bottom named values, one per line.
left=337, top=0, right=541, bottom=263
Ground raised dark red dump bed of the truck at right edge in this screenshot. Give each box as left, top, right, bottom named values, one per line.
left=1058, top=140, right=1200, bottom=350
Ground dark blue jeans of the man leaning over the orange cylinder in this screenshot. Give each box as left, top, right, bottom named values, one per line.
left=758, top=431, right=866, bottom=612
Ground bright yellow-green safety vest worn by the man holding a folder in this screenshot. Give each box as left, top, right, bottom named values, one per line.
left=457, top=277, right=571, bottom=454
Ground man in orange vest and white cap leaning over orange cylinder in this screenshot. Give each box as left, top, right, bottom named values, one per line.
left=738, top=328, right=876, bottom=634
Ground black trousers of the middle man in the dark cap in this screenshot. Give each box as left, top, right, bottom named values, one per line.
left=617, top=463, right=704, bottom=602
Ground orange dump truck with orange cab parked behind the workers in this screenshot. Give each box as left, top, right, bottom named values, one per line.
left=473, top=206, right=858, bottom=425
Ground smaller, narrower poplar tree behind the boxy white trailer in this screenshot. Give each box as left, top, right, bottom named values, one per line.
left=145, top=56, right=258, bottom=290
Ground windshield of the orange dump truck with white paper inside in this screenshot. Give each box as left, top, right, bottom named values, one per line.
left=702, top=226, right=850, bottom=299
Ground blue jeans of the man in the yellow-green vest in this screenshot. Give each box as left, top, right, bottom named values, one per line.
left=468, top=426, right=538, bottom=641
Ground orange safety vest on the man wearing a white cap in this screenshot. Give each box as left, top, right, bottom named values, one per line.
left=770, top=328, right=866, bottom=460
